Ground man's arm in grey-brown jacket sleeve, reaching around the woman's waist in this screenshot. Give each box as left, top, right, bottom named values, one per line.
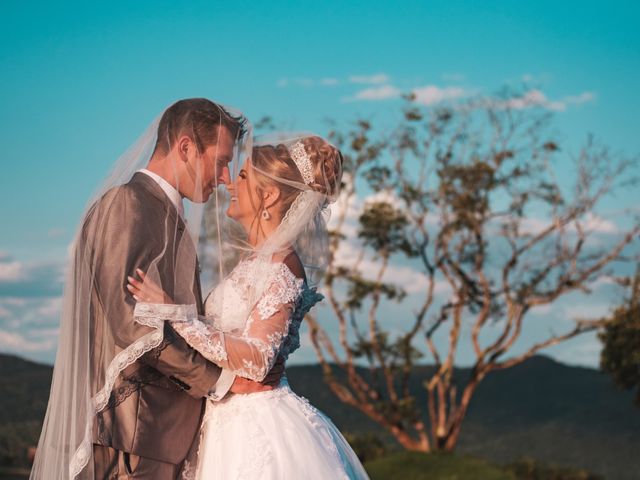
left=88, top=187, right=226, bottom=398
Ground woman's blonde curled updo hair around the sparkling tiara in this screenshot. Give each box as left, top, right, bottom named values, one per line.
left=251, top=136, right=343, bottom=218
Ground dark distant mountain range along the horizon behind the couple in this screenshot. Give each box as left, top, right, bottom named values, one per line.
left=0, top=354, right=640, bottom=480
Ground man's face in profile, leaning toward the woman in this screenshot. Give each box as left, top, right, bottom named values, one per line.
left=181, top=127, right=235, bottom=203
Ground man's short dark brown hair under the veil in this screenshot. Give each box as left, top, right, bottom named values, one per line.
left=153, top=98, right=246, bottom=155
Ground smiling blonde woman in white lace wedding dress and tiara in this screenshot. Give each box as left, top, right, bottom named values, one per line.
left=128, top=136, right=368, bottom=479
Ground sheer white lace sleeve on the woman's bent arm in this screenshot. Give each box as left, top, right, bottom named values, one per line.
left=134, top=264, right=303, bottom=381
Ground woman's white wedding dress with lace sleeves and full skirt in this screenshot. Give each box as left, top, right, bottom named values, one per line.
left=139, top=259, right=368, bottom=480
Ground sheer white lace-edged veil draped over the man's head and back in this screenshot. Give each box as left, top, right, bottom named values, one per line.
left=30, top=99, right=251, bottom=479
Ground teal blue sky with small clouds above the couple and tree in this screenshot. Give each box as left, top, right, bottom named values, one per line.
left=0, top=0, right=640, bottom=366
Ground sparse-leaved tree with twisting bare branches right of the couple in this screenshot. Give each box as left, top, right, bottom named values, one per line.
left=308, top=89, right=640, bottom=452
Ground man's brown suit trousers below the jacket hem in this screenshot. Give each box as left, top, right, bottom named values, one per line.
left=93, top=444, right=182, bottom=480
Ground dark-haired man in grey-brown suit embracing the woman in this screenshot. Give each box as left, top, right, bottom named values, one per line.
left=82, top=99, right=284, bottom=480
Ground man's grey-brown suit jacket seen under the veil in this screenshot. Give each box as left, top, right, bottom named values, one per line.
left=78, top=173, right=221, bottom=464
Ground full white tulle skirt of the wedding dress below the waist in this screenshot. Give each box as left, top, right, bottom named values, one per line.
left=195, top=379, right=369, bottom=480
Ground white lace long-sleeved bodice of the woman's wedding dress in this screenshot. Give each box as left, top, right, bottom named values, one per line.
left=134, top=259, right=322, bottom=381
